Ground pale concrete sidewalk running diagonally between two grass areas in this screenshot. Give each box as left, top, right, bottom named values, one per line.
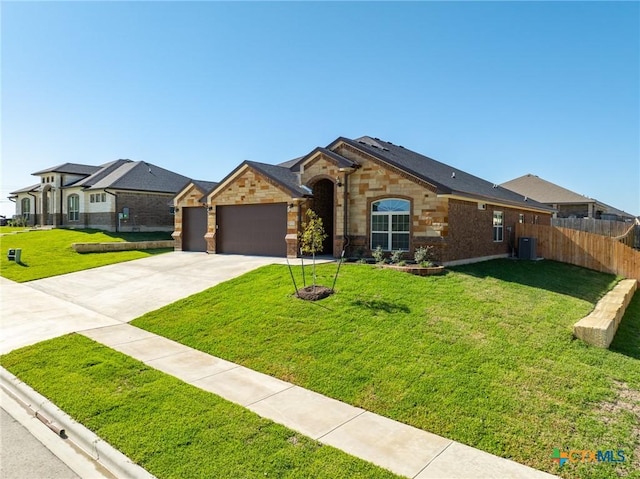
left=82, top=324, right=555, bottom=479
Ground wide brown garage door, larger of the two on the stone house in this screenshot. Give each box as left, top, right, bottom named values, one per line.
left=216, top=203, right=287, bottom=256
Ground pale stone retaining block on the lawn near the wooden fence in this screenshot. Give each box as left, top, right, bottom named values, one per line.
left=573, top=279, right=638, bottom=348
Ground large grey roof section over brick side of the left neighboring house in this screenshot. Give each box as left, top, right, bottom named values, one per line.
left=82, top=160, right=190, bottom=193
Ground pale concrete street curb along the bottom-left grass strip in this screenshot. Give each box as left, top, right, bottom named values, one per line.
left=0, top=367, right=156, bottom=479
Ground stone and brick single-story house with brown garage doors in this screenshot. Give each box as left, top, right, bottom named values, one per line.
left=173, top=136, right=553, bottom=264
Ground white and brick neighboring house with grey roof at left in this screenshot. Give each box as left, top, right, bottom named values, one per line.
left=9, top=160, right=189, bottom=231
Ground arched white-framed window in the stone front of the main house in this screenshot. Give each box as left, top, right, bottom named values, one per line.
left=371, top=198, right=411, bottom=251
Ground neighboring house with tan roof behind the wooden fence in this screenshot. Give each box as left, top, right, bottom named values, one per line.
left=500, top=174, right=634, bottom=221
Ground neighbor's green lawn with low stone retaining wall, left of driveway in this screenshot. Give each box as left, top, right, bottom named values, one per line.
left=0, top=229, right=171, bottom=282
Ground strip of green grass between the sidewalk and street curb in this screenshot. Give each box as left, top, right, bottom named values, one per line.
left=0, top=334, right=397, bottom=479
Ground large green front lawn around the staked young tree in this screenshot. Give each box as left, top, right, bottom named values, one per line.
left=133, top=260, right=640, bottom=479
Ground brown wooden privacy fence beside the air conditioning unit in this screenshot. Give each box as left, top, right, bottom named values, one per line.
left=516, top=223, right=640, bottom=281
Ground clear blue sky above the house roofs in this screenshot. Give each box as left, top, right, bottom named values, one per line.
left=0, top=1, right=640, bottom=215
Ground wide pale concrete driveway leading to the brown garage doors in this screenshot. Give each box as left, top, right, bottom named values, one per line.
left=0, top=252, right=285, bottom=354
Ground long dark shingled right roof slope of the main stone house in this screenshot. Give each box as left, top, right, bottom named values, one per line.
left=336, top=136, right=551, bottom=211
